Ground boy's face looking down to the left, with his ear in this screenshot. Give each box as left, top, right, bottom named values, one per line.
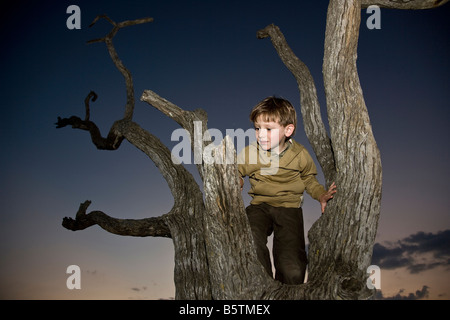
left=254, top=116, right=294, bottom=153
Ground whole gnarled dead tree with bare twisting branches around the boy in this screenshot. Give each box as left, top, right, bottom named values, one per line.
left=56, top=0, right=447, bottom=299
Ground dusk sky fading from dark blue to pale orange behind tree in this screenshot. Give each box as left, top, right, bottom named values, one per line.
left=0, top=0, right=450, bottom=299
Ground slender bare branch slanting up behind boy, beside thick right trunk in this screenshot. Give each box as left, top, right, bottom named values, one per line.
left=257, top=24, right=335, bottom=184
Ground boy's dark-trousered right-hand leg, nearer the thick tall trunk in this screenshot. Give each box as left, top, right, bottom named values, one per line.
left=273, top=208, right=307, bottom=284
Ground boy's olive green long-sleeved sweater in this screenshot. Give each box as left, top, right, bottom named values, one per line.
left=238, top=139, right=326, bottom=208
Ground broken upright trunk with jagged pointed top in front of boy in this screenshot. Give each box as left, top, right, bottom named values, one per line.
left=203, top=136, right=273, bottom=300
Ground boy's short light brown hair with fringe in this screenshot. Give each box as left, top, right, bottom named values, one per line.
left=250, top=97, right=297, bottom=136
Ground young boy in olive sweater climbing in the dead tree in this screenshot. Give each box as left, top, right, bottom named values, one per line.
left=238, top=97, right=336, bottom=284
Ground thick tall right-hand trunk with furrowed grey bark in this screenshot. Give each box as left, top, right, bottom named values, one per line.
left=309, top=0, right=381, bottom=299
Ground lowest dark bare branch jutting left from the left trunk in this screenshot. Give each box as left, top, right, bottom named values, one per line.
left=62, top=200, right=171, bottom=238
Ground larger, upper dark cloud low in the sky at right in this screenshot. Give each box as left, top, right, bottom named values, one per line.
left=372, top=230, right=450, bottom=274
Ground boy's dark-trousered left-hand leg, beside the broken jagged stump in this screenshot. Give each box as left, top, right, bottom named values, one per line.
left=245, top=204, right=273, bottom=277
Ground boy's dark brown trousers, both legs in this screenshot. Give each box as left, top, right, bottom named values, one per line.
left=246, top=203, right=307, bottom=284
